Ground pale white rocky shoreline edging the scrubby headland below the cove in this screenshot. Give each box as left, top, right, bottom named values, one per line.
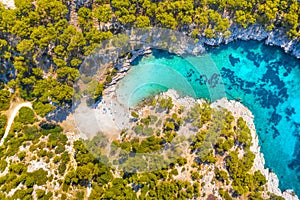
left=154, top=89, right=299, bottom=200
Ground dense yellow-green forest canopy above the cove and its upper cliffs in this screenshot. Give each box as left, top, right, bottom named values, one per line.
left=0, top=0, right=300, bottom=116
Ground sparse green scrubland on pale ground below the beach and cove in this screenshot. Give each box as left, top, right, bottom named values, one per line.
left=0, top=91, right=288, bottom=199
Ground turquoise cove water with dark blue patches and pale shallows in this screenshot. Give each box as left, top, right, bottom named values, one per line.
left=117, top=41, right=300, bottom=195
